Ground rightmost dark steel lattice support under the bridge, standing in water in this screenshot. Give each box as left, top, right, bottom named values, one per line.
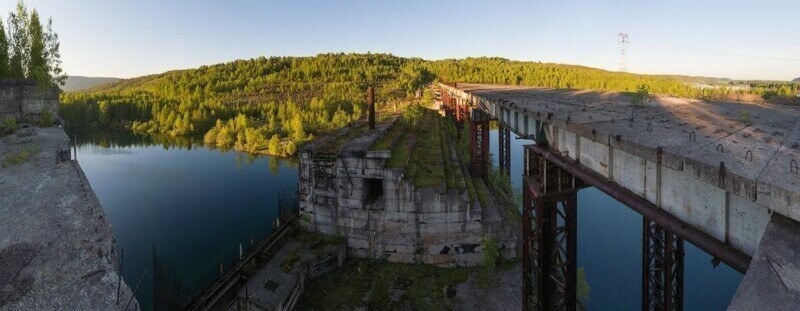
left=642, top=217, right=684, bottom=310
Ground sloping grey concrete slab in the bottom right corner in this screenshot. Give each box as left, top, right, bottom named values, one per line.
left=728, top=214, right=800, bottom=310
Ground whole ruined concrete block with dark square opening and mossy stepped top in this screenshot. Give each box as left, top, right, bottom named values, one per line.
left=299, top=98, right=521, bottom=267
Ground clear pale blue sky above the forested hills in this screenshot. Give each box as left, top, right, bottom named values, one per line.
left=0, top=0, right=800, bottom=80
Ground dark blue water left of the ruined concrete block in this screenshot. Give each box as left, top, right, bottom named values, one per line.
left=68, top=130, right=297, bottom=310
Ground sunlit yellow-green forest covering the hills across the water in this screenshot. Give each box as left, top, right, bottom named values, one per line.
left=62, top=53, right=800, bottom=156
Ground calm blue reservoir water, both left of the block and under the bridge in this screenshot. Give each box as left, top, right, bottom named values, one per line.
left=72, top=131, right=742, bottom=310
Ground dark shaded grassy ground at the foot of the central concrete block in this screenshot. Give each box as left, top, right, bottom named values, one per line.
left=299, top=260, right=477, bottom=310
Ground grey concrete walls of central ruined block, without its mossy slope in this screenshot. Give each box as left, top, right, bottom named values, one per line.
left=299, top=118, right=519, bottom=266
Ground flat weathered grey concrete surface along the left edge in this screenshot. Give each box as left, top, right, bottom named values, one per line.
left=0, top=128, right=138, bottom=310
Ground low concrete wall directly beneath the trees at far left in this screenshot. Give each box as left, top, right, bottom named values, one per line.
left=0, top=80, right=59, bottom=123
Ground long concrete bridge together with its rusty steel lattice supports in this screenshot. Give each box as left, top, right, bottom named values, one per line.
left=439, top=83, right=800, bottom=310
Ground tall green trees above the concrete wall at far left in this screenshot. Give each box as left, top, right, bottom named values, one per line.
left=0, top=0, right=66, bottom=85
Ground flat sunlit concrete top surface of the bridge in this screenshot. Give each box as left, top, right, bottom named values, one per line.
left=458, top=83, right=800, bottom=220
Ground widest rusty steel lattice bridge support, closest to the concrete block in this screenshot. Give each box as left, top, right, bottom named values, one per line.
left=522, top=144, right=583, bottom=310
